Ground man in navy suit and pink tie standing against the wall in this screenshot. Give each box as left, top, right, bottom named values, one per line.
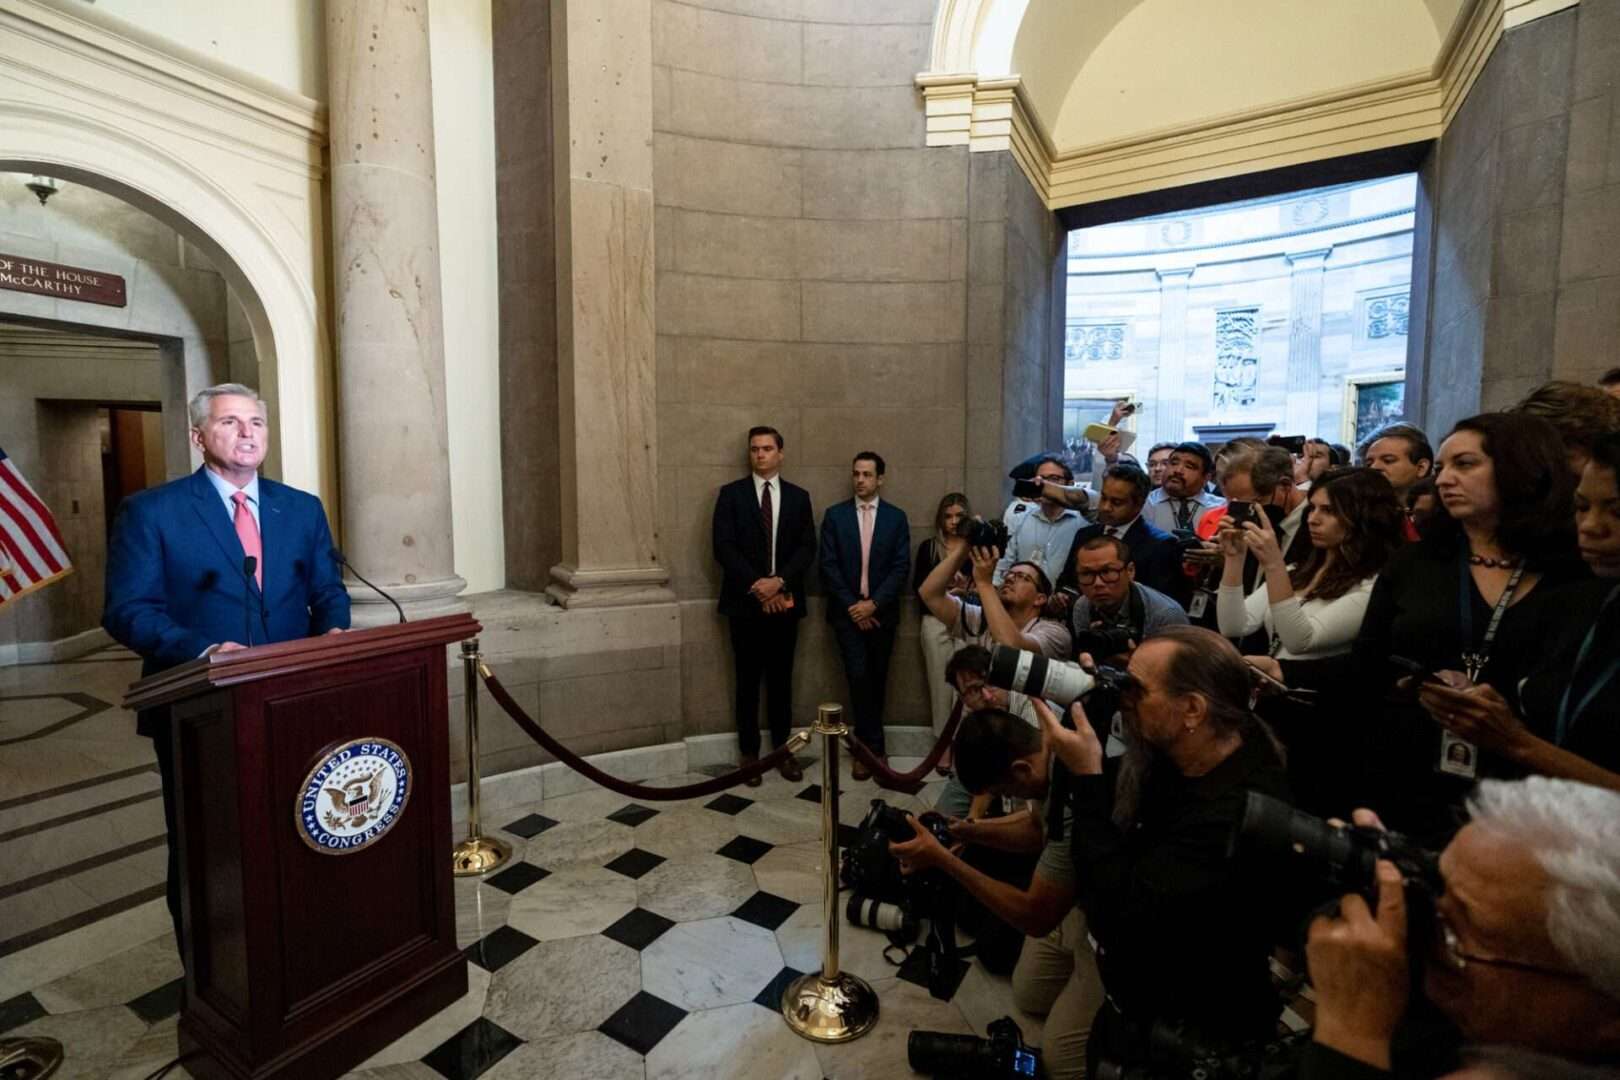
left=821, top=450, right=910, bottom=780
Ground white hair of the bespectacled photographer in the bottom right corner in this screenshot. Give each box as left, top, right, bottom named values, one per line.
left=1468, top=776, right=1620, bottom=1001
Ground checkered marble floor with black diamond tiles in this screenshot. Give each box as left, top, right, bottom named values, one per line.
left=0, top=759, right=1040, bottom=1080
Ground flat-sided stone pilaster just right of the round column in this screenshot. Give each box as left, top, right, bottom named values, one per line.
left=546, top=0, right=674, bottom=607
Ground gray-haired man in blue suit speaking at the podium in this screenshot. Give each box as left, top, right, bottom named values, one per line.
left=102, top=382, right=348, bottom=955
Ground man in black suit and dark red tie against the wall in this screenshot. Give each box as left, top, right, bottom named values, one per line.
left=714, top=427, right=815, bottom=787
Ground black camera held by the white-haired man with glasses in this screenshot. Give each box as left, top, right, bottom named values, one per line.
left=1231, top=792, right=1445, bottom=965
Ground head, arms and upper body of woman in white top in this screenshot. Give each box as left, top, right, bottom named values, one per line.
left=1215, top=468, right=1401, bottom=663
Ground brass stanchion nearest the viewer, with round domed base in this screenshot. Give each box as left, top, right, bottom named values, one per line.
left=782, top=703, right=878, bottom=1043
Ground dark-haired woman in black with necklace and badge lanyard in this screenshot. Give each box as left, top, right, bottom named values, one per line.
left=1346, top=413, right=1589, bottom=847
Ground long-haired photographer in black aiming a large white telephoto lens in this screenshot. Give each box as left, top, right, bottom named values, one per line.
left=1042, top=627, right=1290, bottom=1072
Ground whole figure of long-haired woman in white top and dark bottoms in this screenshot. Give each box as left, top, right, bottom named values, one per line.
left=1215, top=468, right=1405, bottom=814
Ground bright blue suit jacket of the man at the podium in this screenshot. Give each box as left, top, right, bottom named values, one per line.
left=102, top=470, right=348, bottom=675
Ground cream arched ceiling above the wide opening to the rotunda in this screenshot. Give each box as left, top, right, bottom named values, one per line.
left=1004, top=0, right=1466, bottom=155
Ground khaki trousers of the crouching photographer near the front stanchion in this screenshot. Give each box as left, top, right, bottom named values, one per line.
left=1013, top=908, right=1103, bottom=1080
